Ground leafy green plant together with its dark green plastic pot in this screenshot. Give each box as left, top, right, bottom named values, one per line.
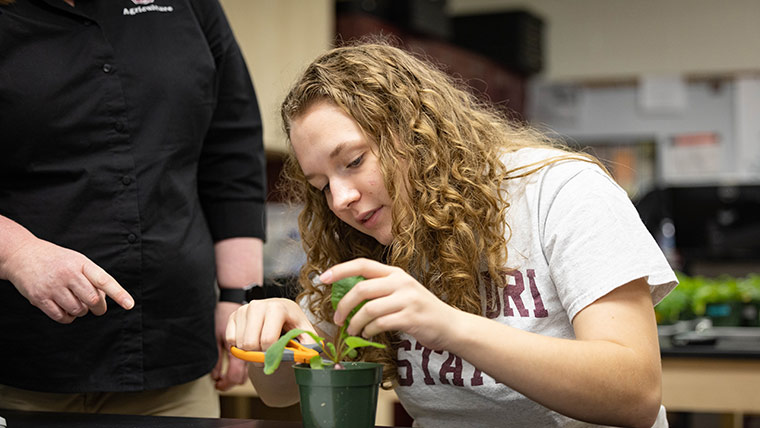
left=264, top=276, right=385, bottom=428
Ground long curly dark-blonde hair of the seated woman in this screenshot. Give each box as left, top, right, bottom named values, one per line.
left=280, top=41, right=600, bottom=381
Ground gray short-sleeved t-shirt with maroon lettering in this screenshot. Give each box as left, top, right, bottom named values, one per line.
left=302, top=149, right=677, bottom=428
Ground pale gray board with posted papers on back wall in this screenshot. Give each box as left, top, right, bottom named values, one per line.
left=528, top=77, right=760, bottom=185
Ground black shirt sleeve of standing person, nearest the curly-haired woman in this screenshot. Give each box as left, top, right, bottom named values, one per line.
left=192, top=0, right=267, bottom=241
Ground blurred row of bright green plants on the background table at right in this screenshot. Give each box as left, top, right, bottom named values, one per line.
left=654, top=272, right=760, bottom=324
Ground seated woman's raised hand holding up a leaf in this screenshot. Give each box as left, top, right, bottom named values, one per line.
left=320, top=259, right=460, bottom=350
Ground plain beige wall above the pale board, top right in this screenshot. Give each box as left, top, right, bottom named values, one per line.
left=447, top=0, right=760, bottom=81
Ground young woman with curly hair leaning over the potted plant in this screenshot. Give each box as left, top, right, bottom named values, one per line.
left=227, top=43, right=676, bottom=427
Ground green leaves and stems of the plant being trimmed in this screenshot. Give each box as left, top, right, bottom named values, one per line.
left=264, top=276, right=385, bottom=374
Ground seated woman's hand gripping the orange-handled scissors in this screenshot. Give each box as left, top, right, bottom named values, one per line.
left=225, top=298, right=315, bottom=358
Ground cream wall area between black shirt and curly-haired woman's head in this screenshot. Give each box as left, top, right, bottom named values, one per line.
left=221, top=0, right=335, bottom=152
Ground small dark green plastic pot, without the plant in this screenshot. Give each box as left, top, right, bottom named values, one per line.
left=293, top=362, right=383, bottom=428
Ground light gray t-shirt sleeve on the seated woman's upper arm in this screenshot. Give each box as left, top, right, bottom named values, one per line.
left=539, top=161, right=677, bottom=319
